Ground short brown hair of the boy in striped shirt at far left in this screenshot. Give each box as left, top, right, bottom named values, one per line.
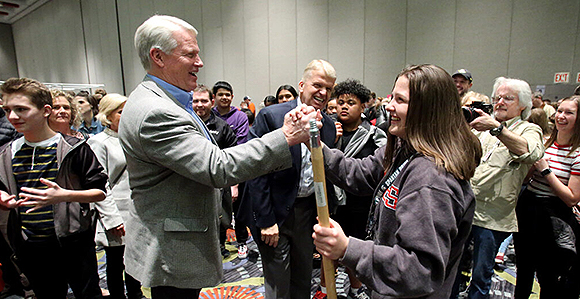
left=0, top=78, right=52, bottom=109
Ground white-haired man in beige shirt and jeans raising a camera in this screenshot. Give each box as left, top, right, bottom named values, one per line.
left=468, top=77, right=544, bottom=298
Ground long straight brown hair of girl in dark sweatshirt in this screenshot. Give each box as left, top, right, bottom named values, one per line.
left=385, top=64, right=482, bottom=180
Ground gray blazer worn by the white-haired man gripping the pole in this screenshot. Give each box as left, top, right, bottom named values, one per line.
left=119, top=77, right=292, bottom=288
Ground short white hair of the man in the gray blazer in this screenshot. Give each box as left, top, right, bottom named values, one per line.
left=135, top=15, right=197, bottom=71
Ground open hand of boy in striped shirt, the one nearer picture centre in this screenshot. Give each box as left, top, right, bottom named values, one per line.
left=19, top=178, right=70, bottom=213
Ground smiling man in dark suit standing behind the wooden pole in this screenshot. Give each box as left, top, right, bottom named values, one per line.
left=238, top=59, right=336, bottom=299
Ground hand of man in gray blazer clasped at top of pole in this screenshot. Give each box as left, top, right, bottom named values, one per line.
left=282, top=104, right=322, bottom=146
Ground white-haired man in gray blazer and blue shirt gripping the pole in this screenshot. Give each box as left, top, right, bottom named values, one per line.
left=119, top=15, right=316, bottom=299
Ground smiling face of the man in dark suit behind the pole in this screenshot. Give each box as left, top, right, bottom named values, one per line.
left=298, top=69, right=336, bottom=110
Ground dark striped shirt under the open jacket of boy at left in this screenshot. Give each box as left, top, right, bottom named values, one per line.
left=12, top=135, right=59, bottom=242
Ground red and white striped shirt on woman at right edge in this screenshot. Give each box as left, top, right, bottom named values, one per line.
left=528, top=142, right=580, bottom=196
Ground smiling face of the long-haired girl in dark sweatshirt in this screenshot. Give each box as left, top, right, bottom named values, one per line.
left=387, top=76, right=410, bottom=139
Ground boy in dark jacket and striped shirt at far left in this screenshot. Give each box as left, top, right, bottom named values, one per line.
left=0, top=78, right=107, bottom=298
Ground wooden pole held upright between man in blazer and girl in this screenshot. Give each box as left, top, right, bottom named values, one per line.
left=310, top=119, right=336, bottom=299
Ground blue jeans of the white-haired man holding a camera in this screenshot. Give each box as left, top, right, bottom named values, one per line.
left=467, top=225, right=510, bottom=299
